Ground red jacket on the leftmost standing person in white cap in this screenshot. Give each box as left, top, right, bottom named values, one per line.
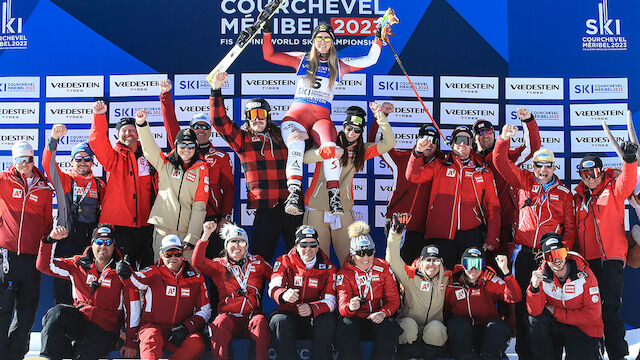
left=0, top=165, right=53, bottom=255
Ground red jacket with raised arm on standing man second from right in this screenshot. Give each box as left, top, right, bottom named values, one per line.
left=493, top=138, right=576, bottom=249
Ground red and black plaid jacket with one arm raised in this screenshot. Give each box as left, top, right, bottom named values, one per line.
left=209, top=89, right=289, bottom=209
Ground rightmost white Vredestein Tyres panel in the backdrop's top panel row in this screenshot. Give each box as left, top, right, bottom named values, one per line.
left=505, top=78, right=564, bottom=100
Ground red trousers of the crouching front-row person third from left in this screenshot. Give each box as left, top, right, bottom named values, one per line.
left=210, top=314, right=271, bottom=360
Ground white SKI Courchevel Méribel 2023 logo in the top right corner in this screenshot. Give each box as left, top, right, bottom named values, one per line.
left=582, top=0, right=628, bottom=51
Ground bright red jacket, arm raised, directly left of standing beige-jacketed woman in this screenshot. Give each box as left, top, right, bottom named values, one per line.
left=89, top=114, right=153, bottom=227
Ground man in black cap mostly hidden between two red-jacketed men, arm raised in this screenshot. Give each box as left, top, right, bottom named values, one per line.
left=473, top=108, right=541, bottom=248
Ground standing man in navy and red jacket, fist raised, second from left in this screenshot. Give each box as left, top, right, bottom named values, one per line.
left=42, top=124, right=105, bottom=305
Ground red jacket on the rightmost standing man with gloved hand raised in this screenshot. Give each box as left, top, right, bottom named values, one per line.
left=574, top=162, right=638, bottom=261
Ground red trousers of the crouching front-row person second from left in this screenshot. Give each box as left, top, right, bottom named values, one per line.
left=138, top=323, right=204, bottom=360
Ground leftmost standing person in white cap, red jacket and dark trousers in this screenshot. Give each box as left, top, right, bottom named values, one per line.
left=0, top=141, right=53, bottom=360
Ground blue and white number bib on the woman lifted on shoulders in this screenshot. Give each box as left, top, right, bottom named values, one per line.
left=293, top=57, right=340, bottom=110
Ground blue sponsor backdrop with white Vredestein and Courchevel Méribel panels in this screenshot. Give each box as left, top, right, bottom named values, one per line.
left=0, top=0, right=640, bottom=327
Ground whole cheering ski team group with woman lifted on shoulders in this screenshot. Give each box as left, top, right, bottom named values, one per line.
left=0, top=24, right=640, bottom=359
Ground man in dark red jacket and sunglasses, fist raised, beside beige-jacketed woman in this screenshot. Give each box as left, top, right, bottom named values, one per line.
left=406, top=126, right=500, bottom=269
